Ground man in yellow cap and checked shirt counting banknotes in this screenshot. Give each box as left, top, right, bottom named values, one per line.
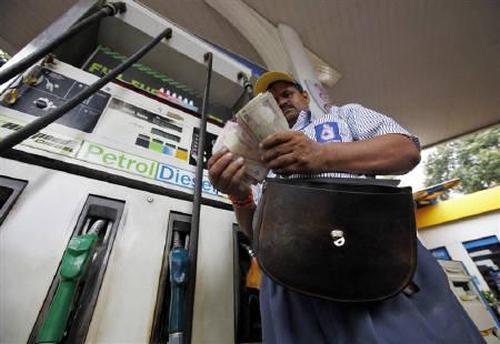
left=208, top=72, right=483, bottom=344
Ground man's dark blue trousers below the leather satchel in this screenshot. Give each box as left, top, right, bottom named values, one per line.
left=260, top=243, right=484, bottom=344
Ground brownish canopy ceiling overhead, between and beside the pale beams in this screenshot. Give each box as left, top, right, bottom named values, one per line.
left=0, top=0, right=500, bottom=146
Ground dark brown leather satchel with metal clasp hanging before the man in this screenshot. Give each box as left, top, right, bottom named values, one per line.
left=254, top=178, right=417, bottom=302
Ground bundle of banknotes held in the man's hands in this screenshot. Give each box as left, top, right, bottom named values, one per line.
left=213, top=92, right=289, bottom=184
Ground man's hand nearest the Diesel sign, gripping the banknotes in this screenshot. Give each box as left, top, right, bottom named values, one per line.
left=208, top=148, right=251, bottom=199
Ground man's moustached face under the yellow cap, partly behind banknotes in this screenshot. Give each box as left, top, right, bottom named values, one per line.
left=268, top=81, right=309, bottom=128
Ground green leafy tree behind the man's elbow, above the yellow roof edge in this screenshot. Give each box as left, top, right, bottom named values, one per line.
left=424, top=126, right=500, bottom=199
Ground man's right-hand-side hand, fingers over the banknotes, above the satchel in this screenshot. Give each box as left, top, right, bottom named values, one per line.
left=261, top=131, right=324, bottom=175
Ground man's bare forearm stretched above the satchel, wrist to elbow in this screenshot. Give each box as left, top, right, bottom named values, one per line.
left=321, top=134, right=420, bottom=174
